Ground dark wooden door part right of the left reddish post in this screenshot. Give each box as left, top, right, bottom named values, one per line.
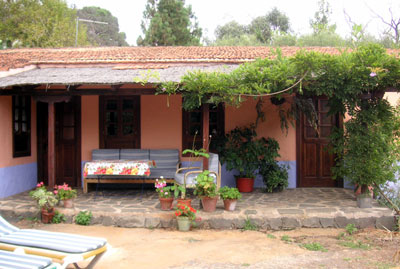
left=55, top=97, right=81, bottom=186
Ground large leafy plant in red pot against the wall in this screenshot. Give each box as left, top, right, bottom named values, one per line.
left=220, top=124, right=279, bottom=192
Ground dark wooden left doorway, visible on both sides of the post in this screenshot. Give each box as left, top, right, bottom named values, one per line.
left=37, top=97, right=81, bottom=187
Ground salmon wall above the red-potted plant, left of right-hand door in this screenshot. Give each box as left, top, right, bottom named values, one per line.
left=225, top=97, right=296, bottom=161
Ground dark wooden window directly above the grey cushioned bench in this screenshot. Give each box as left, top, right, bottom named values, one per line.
left=99, top=96, right=140, bottom=149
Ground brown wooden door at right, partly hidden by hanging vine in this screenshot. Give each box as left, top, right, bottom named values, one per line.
left=297, top=97, right=341, bottom=187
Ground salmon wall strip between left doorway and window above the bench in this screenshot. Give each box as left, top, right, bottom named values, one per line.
left=81, top=96, right=100, bottom=161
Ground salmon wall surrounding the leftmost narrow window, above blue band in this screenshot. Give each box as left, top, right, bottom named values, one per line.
left=0, top=96, right=37, bottom=168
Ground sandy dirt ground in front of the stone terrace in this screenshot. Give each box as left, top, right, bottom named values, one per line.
left=16, top=221, right=400, bottom=269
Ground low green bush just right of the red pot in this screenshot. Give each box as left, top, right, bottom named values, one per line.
left=259, top=161, right=289, bottom=192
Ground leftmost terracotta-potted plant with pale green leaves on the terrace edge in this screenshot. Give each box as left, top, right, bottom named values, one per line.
left=29, top=182, right=58, bottom=223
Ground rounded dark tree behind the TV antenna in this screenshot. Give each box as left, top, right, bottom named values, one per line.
left=78, top=7, right=128, bottom=46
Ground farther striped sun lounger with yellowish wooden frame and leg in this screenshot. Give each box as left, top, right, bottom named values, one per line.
left=0, top=216, right=107, bottom=268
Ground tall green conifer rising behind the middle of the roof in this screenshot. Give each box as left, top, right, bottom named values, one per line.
left=137, top=0, right=202, bottom=46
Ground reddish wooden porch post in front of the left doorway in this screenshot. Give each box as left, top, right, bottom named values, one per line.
left=47, top=102, right=56, bottom=189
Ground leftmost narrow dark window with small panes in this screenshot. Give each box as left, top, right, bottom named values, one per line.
left=12, top=96, right=31, bottom=157
